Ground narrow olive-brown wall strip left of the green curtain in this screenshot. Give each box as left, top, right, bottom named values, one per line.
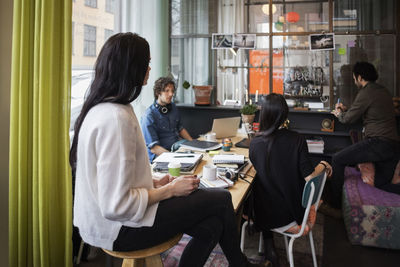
left=0, top=0, right=13, bottom=266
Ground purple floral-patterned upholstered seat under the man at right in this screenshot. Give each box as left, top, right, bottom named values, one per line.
left=342, top=167, right=400, bottom=249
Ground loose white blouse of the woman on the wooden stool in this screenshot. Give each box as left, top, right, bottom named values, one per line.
left=74, top=103, right=158, bottom=250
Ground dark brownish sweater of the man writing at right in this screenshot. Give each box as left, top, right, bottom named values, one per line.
left=338, top=82, right=399, bottom=141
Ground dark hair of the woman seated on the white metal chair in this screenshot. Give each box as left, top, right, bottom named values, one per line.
left=259, top=93, right=289, bottom=168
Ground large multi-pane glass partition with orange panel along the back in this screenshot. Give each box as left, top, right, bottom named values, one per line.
left=170, top=0, right=399, bottom=109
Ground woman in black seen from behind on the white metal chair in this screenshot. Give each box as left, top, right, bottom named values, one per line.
left=249, top=93, right=332, bottom=267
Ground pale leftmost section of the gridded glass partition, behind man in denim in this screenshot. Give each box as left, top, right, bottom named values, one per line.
left=170, top=0, right=218, bottom=103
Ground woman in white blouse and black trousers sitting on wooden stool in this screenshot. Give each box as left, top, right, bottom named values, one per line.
left=70, top=33, right=262, bottom=267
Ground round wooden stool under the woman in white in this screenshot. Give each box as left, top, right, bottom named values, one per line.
left=103, top=234, right=182, bottom=267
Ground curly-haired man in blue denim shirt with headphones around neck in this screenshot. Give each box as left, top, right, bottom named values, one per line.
left=140, top=77, right=192, bottom=162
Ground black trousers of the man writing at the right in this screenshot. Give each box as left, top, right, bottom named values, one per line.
left=331, top=137, right=400, bottom=208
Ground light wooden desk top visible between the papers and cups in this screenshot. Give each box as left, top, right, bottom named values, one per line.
left=188, top=136, right=256, bottom=215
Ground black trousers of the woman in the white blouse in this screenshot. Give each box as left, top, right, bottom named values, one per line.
left=113, top=189, right=246, bottom=267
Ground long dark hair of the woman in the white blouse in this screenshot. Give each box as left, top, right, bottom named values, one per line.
left=69, top=33, right=150, bottom=176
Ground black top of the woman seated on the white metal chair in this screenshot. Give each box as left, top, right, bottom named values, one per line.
left=249, top=129, right=314, bottom=230
